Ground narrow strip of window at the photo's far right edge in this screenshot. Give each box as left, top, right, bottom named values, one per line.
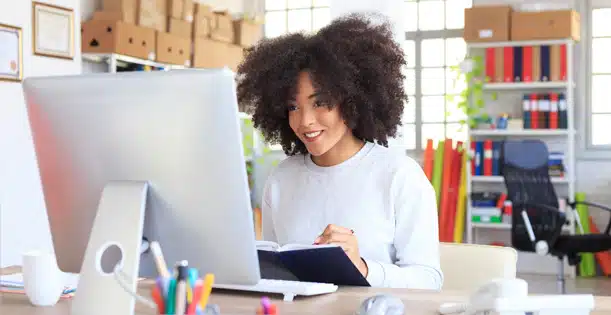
left=589, top=1, right=611, bottom=148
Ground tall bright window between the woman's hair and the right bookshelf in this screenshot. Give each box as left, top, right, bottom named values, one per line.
left=402, top=0, right=472, bottom=150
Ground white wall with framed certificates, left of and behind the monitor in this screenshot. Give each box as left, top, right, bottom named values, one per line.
left=0, top=0, right=81, bottom=267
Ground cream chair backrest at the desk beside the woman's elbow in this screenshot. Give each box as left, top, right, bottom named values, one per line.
left=439, top=243, right=518, bottom=292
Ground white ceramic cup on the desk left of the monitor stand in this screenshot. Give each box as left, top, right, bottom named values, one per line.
left=22, top=251, right=64, bottom=306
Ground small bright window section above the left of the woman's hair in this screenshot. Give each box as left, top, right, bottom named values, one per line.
left=265, top=0, right=331, bottom=37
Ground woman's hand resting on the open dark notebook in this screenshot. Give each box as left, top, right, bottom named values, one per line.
left=314, top=224, right=369, bottom=277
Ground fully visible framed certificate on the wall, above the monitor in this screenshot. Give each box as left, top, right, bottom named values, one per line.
left=32, top=2, right=74, bottom=59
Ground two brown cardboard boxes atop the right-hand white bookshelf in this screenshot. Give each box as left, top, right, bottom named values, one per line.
left=463, top=5, right=580, bottom=42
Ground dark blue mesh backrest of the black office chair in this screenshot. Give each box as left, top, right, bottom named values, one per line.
left=501, top=139, right=564, bottom=252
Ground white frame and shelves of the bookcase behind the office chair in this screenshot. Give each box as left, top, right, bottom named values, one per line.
left=465, top=40, right=576, bottom=277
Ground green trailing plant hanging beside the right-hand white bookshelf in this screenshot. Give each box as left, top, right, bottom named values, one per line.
left=446, top=56, right=489, bottom=128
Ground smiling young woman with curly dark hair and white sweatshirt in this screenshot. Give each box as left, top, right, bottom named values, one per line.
left=237, top=14, right=443, bottom=290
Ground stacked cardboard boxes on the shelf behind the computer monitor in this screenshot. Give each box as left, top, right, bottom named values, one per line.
left=81, top=0, right=262, bottom=71
